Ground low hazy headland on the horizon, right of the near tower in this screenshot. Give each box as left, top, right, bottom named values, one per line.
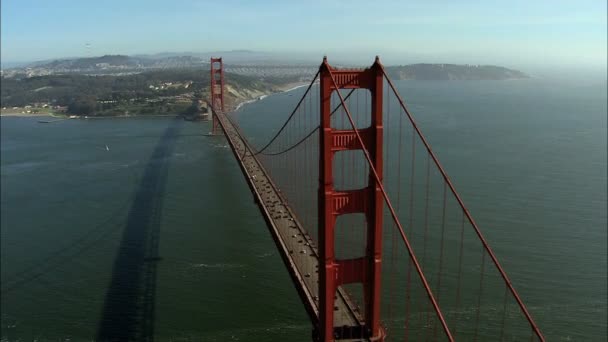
left=386, top=64, right=528, bottom=80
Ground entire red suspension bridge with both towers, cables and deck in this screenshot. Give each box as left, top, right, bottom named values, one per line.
left=209, top=57, right=545, bottom=341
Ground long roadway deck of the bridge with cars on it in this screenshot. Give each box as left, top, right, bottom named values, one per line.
left=217, top=113, right=365, bottom=340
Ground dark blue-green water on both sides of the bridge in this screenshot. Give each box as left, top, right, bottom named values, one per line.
left=0, top=79, right=608, bottom=341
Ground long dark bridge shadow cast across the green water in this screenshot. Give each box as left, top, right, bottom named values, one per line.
left=97, top=118, right=183, bottom=341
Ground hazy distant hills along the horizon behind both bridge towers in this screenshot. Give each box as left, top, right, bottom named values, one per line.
left=2, top=50, right=529, bottom=80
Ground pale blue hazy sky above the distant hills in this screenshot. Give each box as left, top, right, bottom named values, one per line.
left=1, top=0, right=607, bottom=69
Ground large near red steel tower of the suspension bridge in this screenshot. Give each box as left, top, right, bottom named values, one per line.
left=318, top=57, right=385, bottom=341
